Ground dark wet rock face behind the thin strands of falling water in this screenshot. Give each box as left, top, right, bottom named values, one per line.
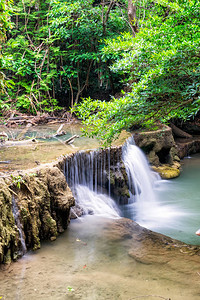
left=66, top=146, right=130, bottom=203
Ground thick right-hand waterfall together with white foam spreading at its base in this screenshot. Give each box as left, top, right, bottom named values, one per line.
left=123, top=139, right=184, bottom=229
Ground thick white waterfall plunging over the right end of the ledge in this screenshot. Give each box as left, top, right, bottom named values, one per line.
left=122, top=138, right=160, bottom=228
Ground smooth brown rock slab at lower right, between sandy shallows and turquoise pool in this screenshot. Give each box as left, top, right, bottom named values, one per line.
left=103, top=218, right=200, bottom=265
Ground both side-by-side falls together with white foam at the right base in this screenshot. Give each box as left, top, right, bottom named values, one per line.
left=65, top=138, right=182, bottom=230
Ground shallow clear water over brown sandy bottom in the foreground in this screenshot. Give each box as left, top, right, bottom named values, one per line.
left=0, top=216, right=200, bottom=300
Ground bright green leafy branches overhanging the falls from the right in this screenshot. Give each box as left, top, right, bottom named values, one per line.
left=75, top=0, right=200, bottom=145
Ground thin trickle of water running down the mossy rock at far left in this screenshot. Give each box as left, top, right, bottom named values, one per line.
left=12, top=195, right=27, bottom=255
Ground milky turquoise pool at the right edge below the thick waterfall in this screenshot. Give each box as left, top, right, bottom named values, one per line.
left=147, top=154, right=200, bottom=245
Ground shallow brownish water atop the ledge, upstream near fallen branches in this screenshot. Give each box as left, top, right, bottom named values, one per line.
left=0, top=123, right=99, bottom=172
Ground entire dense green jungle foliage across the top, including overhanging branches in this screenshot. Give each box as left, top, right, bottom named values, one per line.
left=0, top=0, right=200, bottom=144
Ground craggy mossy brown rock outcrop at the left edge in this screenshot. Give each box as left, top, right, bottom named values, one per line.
left=0, top=161, right=74, bottom=263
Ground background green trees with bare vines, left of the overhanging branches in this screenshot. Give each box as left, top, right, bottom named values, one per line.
left=0, top=0, right=127, bottom=114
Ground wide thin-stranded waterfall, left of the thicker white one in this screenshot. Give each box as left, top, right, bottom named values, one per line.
left=65, top=149, right=119, bottom=218
